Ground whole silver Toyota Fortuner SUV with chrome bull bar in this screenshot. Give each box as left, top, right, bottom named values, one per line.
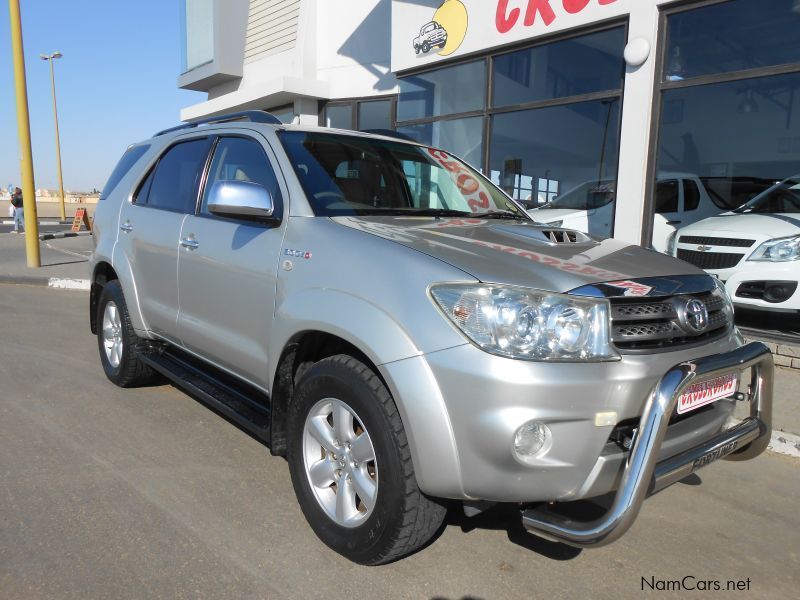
left=90, top=112, right=772, bottom=564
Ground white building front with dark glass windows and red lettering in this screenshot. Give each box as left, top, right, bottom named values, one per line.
left=178, top=0, right=800, bottom=250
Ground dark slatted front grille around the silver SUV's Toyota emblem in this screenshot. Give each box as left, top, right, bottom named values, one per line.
left=611, top=292, right=731, bottom=352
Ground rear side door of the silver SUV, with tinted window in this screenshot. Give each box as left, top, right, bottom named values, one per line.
left=118, top=136, right=211, bottom=343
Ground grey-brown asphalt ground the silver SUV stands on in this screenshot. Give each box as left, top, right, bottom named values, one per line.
left=0, top=285, right=800, bottom=600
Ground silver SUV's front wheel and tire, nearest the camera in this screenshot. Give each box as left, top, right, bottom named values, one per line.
left=287, top=354, right=446, bottom=565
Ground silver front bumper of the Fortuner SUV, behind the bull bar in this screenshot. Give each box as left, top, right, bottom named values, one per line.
left=380, top=331, right=768, bottom=503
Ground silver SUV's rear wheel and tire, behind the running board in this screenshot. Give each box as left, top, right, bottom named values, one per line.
left=97, top=280, right=155, bottom=387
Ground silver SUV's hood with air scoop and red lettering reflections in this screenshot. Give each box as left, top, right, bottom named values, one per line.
left=333, top=217, right=703, bottom=292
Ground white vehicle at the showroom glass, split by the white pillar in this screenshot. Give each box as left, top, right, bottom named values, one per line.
left=529, top=173, right=720, bottom=252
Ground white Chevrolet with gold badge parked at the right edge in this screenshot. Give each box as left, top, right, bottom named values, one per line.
left=671, top=175, right=800, bottom=313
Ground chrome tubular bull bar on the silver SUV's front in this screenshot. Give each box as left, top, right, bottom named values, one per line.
left=522, top=342, right=774, bottom=548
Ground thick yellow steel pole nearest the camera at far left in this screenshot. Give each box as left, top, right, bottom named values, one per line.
left=8, top=0, right=42, bottom=268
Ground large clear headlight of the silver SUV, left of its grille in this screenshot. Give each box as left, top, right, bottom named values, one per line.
left=431, top=284, right=619, bottom=361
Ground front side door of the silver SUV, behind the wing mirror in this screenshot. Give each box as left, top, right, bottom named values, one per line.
left=178, top=134, right=286, bottom=389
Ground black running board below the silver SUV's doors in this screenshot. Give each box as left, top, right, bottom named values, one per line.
left=137, top=347, right=270, bottom=444
